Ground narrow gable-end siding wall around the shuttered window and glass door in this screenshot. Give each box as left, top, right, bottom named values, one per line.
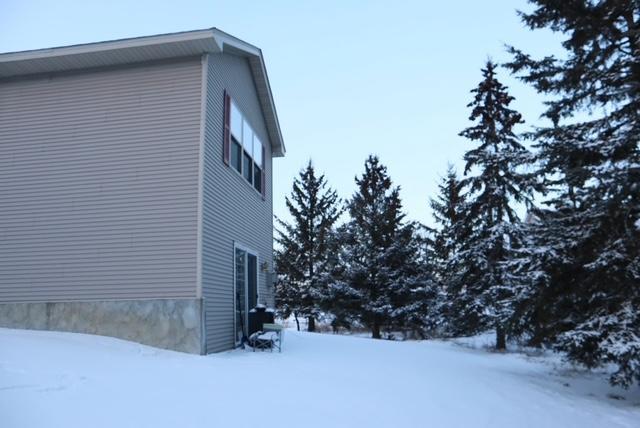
left=202, top=54, right=273, bottom=352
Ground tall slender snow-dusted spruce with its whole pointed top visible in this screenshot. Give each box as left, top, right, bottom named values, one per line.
left=450, top=61, right=534, bottom=349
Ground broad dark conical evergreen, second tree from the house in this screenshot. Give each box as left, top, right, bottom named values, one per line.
left=334, top=156, right=431, bottom=338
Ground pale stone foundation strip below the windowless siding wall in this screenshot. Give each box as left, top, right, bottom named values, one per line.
left=0, top=299, right=204, bottom=354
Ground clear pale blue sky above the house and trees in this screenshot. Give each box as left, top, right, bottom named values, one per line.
left=0, top=0, right=561, bottom=225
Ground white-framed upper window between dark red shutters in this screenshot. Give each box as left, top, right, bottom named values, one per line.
left=229, top=100, right=264, bottom=193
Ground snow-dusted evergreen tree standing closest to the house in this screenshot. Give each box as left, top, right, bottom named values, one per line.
left=275, top=161, right=341, bottom=331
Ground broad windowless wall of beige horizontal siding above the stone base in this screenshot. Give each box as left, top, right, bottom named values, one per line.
left=0, top=58, right=202, bottom=302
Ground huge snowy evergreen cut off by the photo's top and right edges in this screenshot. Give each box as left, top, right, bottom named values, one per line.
left=507, top=0, right=640, bottom=385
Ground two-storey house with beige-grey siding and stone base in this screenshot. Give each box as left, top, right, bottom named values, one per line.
left=0, top=28, right=285, bottom=354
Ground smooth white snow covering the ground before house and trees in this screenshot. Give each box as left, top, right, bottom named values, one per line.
left=0, top=329, right=640, bottom=428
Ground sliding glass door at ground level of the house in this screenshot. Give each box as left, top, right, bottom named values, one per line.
left=234, top=246, right=258, bottom=345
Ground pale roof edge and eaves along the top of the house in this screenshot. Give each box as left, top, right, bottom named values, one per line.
left=0, top=28, right=285, bottom=156
